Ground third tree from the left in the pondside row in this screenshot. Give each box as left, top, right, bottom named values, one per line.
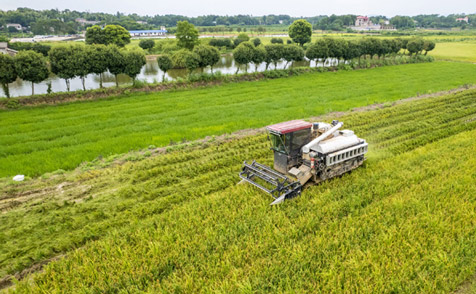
left=49, top=45, right=82, bottom=92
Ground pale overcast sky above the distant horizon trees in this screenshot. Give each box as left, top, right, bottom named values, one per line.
left=0, top=0, right=476, bottom=17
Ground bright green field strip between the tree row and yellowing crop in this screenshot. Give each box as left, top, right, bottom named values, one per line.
left=0, top=62, right=476, bottom=176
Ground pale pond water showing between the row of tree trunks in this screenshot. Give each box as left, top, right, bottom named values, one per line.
left=0, top=55, right=336, bottom=97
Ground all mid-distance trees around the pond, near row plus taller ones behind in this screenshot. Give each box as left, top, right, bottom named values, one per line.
left=0, top=19, right=435, bottom=97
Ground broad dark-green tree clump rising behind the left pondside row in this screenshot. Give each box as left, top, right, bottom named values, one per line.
left=86, top=25, right=131, bottom=47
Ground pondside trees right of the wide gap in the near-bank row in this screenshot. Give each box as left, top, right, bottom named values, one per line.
left=157, top=38, right=435, bottom=77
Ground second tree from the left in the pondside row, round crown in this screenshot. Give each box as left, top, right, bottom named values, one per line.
left=15, top=50, right=49, bottom=95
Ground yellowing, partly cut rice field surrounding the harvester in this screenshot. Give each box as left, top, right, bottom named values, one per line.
left=0, top=90, right=476, bottom=293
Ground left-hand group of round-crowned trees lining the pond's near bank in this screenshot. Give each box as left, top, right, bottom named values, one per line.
left=0, top=44, right=146, bottom=97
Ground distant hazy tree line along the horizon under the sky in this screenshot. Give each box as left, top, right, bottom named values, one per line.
left=0, top=8, right=476, bottom=35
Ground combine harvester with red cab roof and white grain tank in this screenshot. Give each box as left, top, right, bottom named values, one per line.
left=240, top=120, right=368, bottom=205
